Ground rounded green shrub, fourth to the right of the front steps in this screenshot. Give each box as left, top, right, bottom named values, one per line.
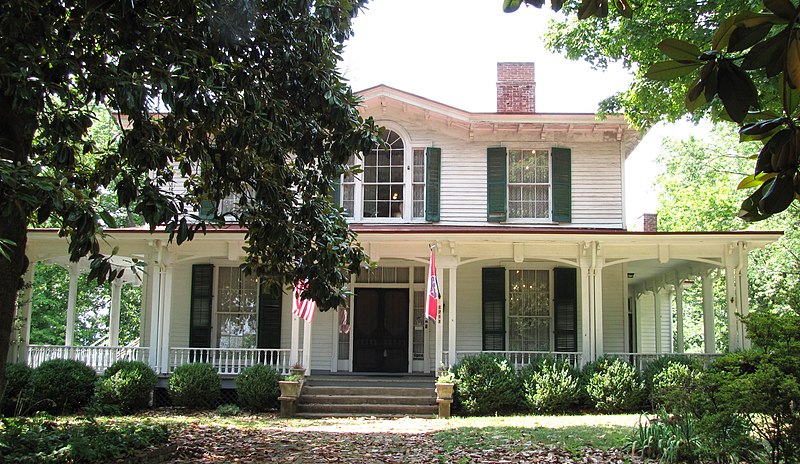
left=645, top=362, right=701, bottom=414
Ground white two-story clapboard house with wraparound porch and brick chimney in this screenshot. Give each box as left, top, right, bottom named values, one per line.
left=12, top=63, right=780, bottom=374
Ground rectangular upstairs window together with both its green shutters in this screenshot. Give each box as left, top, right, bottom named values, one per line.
left=486, top=147, right=572, bottom=222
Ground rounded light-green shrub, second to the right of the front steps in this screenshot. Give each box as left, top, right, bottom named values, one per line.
left=521, top=359, right=581, bottom=413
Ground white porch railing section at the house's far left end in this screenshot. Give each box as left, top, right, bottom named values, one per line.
left=28, top=345, right=150, bottom=374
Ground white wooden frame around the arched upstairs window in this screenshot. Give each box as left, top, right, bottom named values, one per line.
left=339, top=125, right=428, bottom=223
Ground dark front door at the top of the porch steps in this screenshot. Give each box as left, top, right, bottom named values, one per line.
left=353, top=288, right=408, bottom=372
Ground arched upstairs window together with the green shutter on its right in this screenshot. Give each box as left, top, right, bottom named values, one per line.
left=340, top=130, right=441, bottom=221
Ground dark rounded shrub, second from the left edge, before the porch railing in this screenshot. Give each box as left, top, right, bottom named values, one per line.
left=30, top=359, right=97, bottom=414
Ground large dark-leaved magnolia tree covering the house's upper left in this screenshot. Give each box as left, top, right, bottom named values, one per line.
left=0, top=0, right=378, bottom=402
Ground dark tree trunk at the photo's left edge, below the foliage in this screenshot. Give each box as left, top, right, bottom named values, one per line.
left=0, top=217, right=28, bottom=404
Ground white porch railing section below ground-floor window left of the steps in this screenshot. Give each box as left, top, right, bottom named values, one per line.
left=169, top=348, right=294, bottom=375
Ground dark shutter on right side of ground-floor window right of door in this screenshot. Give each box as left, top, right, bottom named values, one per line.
left=553, top=267, right=578, bottom=352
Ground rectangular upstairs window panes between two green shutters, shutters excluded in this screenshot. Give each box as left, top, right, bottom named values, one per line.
left=508, top=150, right=550, bottom=219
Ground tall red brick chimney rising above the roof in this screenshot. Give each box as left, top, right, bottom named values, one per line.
left=497, top=63, right=536, bottom=113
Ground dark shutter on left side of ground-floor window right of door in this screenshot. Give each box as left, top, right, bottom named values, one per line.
left=481, top=267, right=506, bottom=351
